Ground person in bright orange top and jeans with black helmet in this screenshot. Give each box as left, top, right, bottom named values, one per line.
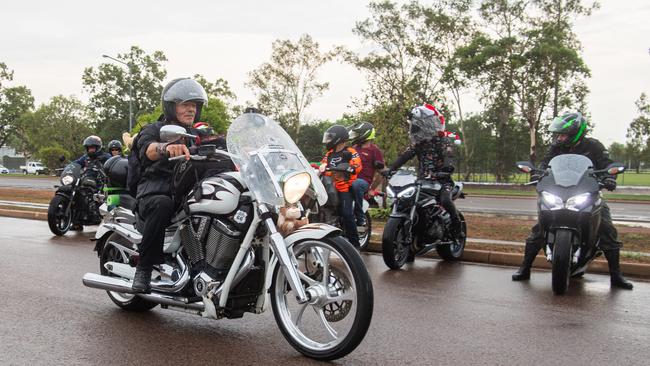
left=319, top=125, right=361, bottom=248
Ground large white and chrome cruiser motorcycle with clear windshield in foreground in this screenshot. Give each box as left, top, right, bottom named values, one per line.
left=83, top=113, right=373, bottom=360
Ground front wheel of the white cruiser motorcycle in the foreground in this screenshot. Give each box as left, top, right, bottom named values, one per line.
left=270, top=236, right=374, bottom=361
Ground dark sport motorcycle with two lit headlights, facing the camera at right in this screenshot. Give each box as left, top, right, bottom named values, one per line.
left=517, top=154, right=625, bottom=295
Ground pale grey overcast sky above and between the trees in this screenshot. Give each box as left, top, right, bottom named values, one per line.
left=0, top=0, right=650, bottom=145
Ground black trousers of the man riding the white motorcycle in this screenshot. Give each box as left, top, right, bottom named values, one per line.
left=138, top=195, right=174, bottom=267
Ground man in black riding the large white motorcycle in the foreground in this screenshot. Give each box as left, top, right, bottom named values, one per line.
left=129, top=78, right=208, bottom=293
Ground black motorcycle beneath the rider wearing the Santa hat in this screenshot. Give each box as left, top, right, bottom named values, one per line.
left=381, top=170, right=467, bottom=269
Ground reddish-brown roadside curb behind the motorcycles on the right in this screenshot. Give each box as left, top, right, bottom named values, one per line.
left=365, top=241, right=650, bottom=278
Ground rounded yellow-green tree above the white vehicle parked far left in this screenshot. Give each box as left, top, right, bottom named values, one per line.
left=16, top=95, right=94, bottom=157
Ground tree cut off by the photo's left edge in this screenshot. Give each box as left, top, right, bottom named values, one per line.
left=0, top=62, right=34, bottom=147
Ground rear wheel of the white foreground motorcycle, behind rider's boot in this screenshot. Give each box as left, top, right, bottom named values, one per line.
left=99, top=233, right=158, bottom=312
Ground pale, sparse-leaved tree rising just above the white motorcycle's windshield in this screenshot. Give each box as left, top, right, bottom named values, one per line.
left=247, top=34, right=341, bottom=139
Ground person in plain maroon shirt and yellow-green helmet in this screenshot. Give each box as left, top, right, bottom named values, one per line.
left=350, top=122, right=385, bottom=226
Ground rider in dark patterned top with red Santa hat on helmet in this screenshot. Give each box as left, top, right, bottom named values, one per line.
left=382, top=104, right=464, bottom=239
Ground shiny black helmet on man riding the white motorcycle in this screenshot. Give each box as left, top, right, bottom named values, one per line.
left=161, top=78, right=208, bottom=123
